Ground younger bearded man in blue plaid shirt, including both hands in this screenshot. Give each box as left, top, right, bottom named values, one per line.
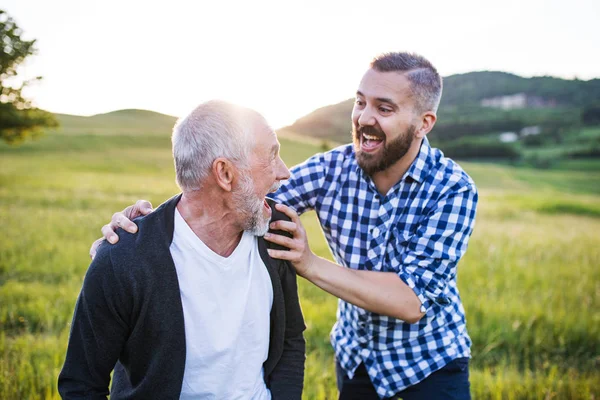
left=92, top=52, right=478, bottom=400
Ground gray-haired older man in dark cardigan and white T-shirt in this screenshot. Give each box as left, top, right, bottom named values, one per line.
left=58, top=101, right=305, bottom=399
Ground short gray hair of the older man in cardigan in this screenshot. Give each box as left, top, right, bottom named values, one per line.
left=171, top=100, right=262, bottom=191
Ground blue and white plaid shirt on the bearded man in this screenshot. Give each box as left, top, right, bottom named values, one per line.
left=275, top=139, right=477, bottom=397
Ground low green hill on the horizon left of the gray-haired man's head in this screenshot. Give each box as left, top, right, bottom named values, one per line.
left=55, top=110, right=177, bottom=135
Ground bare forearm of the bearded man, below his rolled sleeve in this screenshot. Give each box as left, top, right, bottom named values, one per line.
left=303, top=255, right=423, bottom=323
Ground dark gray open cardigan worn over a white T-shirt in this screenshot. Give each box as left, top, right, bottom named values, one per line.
left=58, top=195, right=305, bottom=399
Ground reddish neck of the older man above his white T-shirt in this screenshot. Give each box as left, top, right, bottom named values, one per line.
left=177, top=190, right=244, bottom=257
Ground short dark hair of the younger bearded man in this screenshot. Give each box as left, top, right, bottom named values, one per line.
left=370, top=52, right=442, bottom=112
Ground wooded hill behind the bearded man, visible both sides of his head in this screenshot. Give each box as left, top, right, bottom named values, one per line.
left=285, top=71, right=600, bottom=142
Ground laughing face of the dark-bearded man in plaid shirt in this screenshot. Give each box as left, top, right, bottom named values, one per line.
left=352, top=69, right=419, bottom=175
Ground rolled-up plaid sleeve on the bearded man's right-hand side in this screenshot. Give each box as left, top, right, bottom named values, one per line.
left=399, top=184, right=478, bottom=313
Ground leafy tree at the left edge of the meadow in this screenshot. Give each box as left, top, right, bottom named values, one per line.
left=0, top=10, right=58, bottom=143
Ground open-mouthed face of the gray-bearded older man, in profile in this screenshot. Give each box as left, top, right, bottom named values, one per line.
left=233, top=119, right=290, bottom=236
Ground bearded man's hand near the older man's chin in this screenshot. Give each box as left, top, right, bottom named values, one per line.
left=265, top=204, right=316, bottom=277
